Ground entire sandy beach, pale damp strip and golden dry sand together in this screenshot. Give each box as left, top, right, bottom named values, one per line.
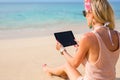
left=0, top=21, right=120, bottom=80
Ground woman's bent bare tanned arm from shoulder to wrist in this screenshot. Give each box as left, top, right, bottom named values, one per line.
left=58, top=34, right=90, bottom=67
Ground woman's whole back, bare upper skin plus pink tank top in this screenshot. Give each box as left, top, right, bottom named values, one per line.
left=85, top=28, right=120, bottom=80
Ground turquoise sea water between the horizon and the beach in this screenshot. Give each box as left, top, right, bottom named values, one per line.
left=0, top=2, right=120, bottom=30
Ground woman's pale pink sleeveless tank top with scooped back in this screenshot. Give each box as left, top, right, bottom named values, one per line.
left=84, top=31, right=120, bottom=80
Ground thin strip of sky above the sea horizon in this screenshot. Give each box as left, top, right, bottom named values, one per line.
left=0, top=0, right=120, bottom=2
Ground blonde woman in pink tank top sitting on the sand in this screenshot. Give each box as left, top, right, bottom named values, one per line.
left=43, top=0, right=120, bottom=80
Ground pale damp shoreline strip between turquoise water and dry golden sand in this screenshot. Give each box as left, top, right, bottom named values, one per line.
left=0, top=20, right=120, bottom=40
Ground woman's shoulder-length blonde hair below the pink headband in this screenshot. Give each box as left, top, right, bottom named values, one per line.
left=91, top=0, right=115, bottom=29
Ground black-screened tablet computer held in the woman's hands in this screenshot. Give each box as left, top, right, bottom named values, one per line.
left=54, top=31, right=77, bottom=47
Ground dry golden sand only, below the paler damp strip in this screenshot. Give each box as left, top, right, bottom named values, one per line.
left=0, top=34, right=120, bottom=80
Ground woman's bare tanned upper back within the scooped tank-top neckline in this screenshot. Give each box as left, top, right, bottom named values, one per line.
left=97, top=28, right=119, bottom=52
